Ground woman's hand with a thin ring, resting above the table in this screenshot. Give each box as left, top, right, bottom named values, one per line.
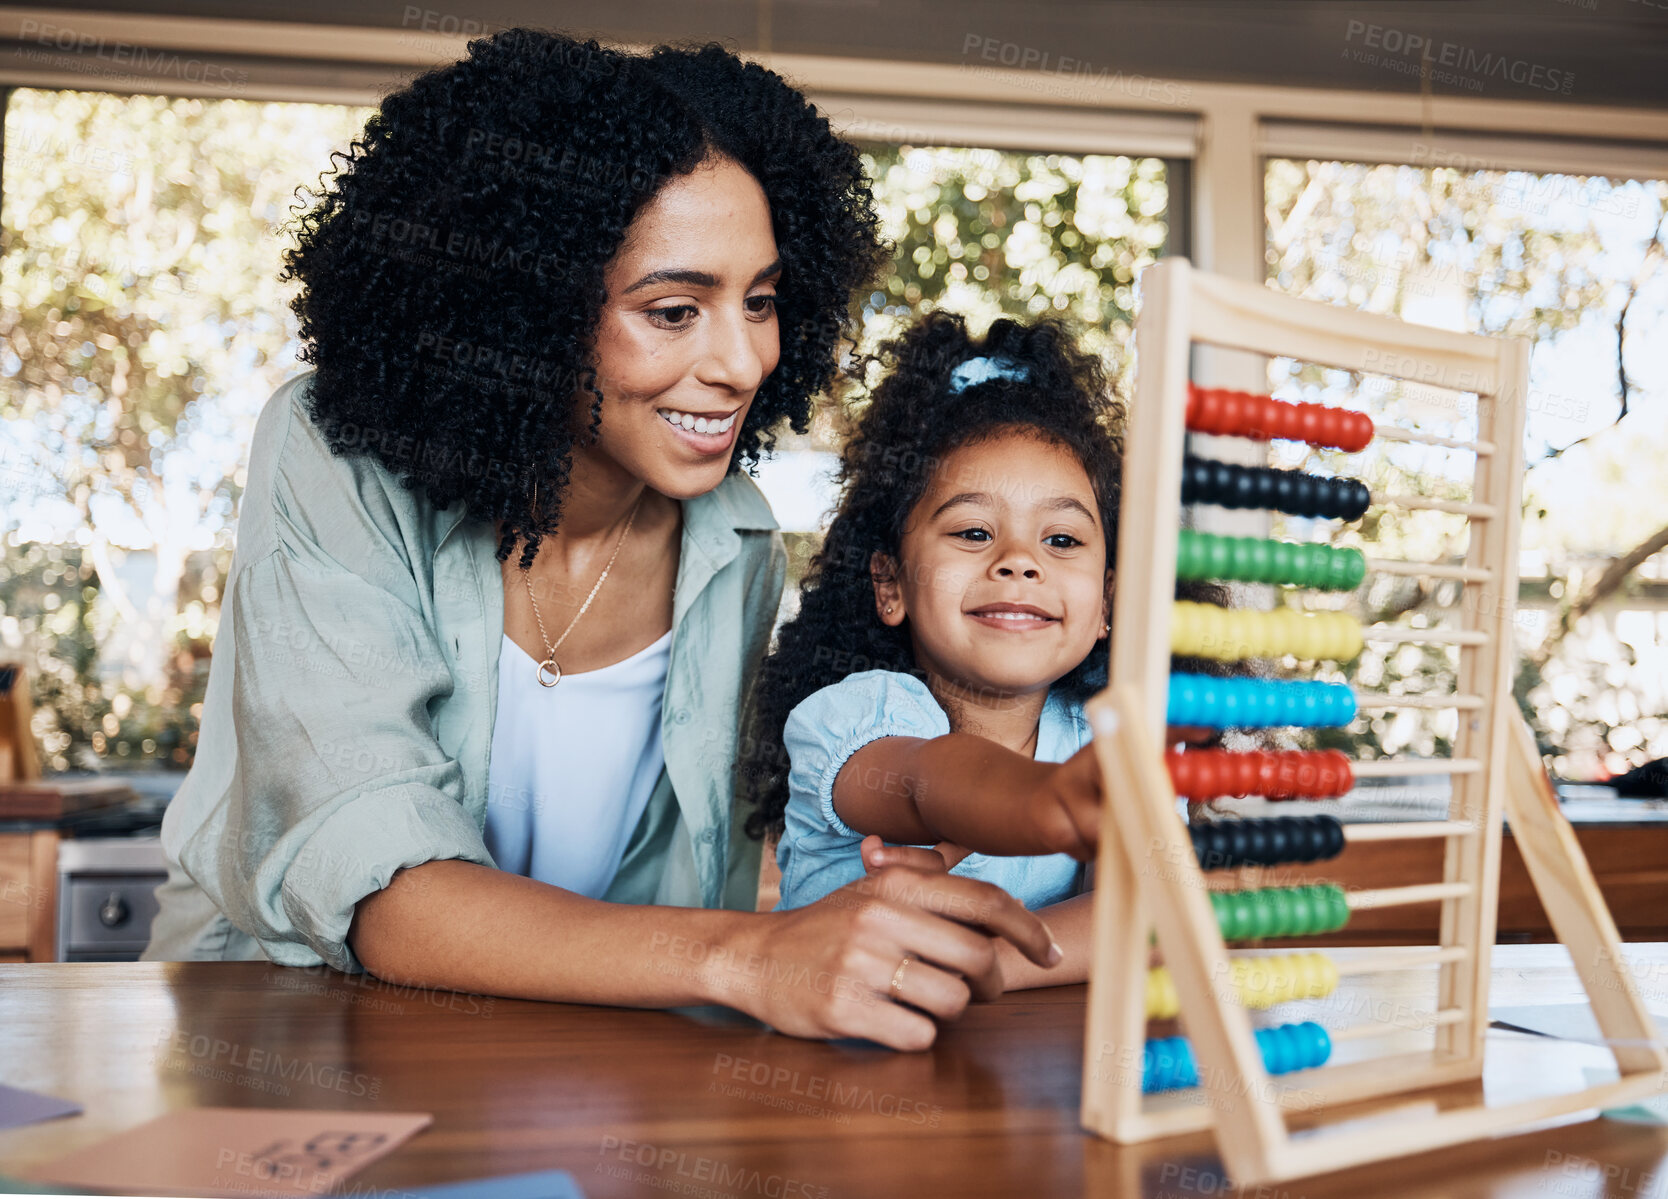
left=707, top=873, right=1061, bottom=1049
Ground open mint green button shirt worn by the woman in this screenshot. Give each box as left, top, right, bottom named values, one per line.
left=145, top=374, right=787, bottom=971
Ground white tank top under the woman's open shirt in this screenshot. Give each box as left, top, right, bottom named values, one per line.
left=485, top=630, right=672, bottom=899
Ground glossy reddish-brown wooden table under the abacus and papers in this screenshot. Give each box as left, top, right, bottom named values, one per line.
left=0, top=944, right=1668, bottom=1199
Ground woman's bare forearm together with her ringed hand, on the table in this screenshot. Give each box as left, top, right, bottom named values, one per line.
left=349, top=859, right=1061, bottom=1049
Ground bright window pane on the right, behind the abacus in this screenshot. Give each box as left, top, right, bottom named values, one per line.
left=1264, top=160, right=1668, bottom=779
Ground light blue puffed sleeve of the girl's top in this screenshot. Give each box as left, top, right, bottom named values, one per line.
left=777, top=670, right=949, bottom=909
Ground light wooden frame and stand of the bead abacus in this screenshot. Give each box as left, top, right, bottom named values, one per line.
left=1081, top=258, right=1668, bottom=1184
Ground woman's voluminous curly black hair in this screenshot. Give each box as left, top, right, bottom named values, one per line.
left=284, top=28, right=886, bottom=567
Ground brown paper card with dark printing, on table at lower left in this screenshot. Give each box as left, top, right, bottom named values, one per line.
left=27, top=1107, right=434, bottom=1199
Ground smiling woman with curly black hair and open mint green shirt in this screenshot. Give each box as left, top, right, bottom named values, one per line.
left=147, top=30, right=1058, bottom=1047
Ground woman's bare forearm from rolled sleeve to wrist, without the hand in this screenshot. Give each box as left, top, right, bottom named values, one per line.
left=349, top=860, right=759, bottom=1007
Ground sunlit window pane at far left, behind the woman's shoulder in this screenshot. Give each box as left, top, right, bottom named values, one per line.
left=0, top=90, right=369, bottom=770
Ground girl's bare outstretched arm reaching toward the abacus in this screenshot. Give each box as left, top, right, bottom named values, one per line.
left=834, top=732, right=1101, bottom=859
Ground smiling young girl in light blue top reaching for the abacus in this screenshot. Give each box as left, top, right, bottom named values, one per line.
left=742, top=312, right=1121, bottom=987
